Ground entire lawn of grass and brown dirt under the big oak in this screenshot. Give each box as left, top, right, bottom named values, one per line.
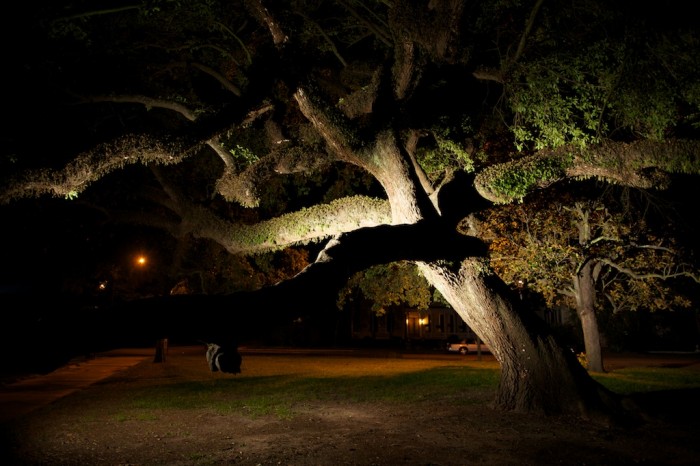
left=0, top=348, right=700, bottom=466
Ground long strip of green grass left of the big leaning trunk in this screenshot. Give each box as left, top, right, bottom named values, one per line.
left=123, top=367, right=498, bottom=418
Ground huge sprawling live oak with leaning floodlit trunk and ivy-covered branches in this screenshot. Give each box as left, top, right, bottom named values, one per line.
left=2, top=0, right=700, bottom=417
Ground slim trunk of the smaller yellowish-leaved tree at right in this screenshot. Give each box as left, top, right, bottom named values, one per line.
left=574, top=261, right=604, bottom=372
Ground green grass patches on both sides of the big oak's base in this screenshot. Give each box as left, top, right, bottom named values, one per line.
left=106, top=366, right=700, bottom=420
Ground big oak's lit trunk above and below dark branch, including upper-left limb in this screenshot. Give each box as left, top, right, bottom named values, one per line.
left=295, top=62, right=618, bottom=417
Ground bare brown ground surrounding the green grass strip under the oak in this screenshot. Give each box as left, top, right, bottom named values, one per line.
left=0, top=349, right=700, bottom=465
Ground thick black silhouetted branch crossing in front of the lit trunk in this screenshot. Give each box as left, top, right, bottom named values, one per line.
left=109, top=218, right=487, bottom=345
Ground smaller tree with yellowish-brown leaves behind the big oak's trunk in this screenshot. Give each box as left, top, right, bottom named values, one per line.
left=481, top=185, right=698, bottom=372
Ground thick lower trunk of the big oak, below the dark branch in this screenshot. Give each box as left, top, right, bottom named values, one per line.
left=421, top=259, right=620, bottom=420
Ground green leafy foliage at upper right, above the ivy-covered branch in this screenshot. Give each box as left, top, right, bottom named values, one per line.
left=505, top=2, right=700, bottom=151
